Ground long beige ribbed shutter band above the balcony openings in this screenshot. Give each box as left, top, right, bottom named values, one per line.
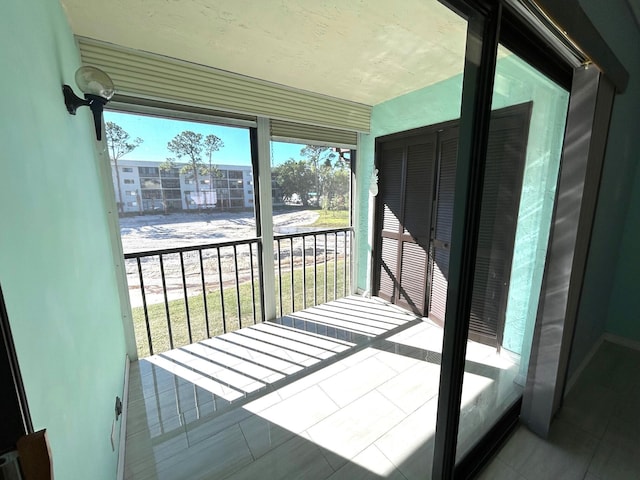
left=76, top=37, right=371, bottom=134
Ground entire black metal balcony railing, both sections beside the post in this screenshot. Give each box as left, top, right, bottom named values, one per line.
left=124, top=228, right=352, bottom=358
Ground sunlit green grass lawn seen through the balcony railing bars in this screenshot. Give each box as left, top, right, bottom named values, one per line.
left=132, top=258, right=349, bottom=358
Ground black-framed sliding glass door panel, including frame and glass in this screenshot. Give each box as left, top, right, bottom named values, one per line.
left=432, top=3, right=572, bottom=479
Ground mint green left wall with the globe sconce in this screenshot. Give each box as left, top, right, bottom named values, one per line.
left=0, top=0, right=125, bottom=480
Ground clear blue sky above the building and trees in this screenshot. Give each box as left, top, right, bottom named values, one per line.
left=104, top=111, right=304, bottom=165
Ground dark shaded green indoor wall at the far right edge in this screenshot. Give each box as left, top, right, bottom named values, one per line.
left=569, top=0, right=640, bottom=373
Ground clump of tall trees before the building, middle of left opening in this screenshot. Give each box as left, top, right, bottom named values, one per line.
left=160, top=130, right=224, bottom=207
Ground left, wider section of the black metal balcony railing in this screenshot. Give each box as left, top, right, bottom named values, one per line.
left=124, top=238, right=264, bottom=357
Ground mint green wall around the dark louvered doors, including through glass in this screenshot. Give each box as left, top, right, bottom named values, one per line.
left=357, top=56, right=569, bottom=372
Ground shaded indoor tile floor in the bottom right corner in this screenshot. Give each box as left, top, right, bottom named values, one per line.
left=480, top=342, right=640, bottom=480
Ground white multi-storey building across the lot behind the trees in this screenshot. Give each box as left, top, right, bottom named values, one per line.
left=111, top=160, right=254, bottom=214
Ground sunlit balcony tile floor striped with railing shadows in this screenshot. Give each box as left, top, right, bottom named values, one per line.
left=125, top=296, right=519, bottom=480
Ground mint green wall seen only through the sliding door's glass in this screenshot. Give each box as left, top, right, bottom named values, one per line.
left=492, top=55, right=569, bottom=364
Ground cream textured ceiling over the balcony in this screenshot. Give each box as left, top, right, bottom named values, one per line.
left=61, top=0, right=466, bottom=105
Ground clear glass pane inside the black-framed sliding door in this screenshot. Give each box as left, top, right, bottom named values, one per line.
left=456, top=45, right=569, bottom=461
